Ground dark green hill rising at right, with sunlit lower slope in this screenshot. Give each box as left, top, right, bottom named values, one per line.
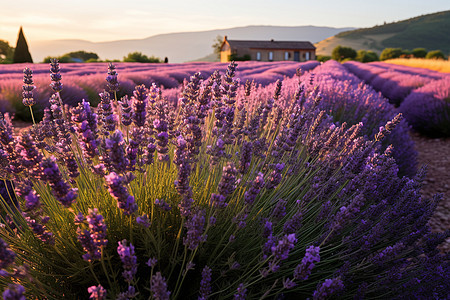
left=315, top=10, right=450, bottom=55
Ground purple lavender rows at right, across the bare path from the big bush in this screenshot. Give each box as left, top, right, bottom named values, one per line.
left=344, top=62, right=450, bottom=136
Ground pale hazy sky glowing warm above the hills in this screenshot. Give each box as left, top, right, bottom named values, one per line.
left=0, top=0, right=450, bottom=46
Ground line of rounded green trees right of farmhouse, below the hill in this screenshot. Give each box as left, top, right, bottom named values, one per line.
left=317, top=45, right=446, bottom=62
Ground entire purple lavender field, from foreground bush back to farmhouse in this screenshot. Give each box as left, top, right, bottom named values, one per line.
left=0, top=61, right=450, bottom=299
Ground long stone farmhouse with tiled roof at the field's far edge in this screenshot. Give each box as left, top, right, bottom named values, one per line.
left=220, top=36, right=316, bottom=62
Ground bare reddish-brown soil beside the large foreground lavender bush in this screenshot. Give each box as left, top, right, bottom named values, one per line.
left=8, top=121, right=450, bottom=252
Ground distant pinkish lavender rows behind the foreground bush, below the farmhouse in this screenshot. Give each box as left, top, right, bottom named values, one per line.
left=0, top=61, right=319, bottom=121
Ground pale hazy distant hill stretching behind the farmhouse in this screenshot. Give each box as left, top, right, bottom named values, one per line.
left=29, top=26, right=354, bottom=63
